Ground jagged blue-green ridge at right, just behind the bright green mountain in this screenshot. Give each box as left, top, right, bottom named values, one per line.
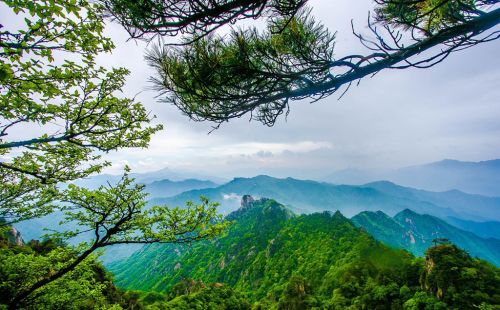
left=351, top=210, right=500, bottom=266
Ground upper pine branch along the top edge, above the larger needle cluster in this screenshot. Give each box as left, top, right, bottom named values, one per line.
left=101, top=0, right=307, bottom=40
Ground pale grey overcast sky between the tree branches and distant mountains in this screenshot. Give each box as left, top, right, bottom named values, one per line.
left=17, top=0, right=500, bottom=178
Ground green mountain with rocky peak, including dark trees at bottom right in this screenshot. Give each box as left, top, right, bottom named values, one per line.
left=110, top=196, right=500, bottom=309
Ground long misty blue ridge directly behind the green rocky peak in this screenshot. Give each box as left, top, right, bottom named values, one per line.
left=151, top=176, right=500, bottom=221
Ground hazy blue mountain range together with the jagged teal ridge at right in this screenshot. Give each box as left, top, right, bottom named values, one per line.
left=148, top=176, right=500, bottom=265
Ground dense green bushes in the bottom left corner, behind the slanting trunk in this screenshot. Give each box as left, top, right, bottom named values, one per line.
left=0, top=232, right=140, bottom=309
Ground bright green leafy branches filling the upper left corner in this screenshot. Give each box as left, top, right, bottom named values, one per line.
left=0, top=0, right=161, bottom=222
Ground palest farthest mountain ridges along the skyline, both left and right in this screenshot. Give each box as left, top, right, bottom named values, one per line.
left=76, top=159, right=500, bottom=197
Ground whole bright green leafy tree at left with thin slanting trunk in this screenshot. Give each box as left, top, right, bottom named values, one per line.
left=0, top=0, right=226, bottom=308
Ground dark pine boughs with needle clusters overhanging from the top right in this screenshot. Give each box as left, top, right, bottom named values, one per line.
left=103, top=0, right=500, bottom=126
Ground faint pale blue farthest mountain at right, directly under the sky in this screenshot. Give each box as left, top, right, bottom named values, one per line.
left=323, top=159, right=500, bottom=196
